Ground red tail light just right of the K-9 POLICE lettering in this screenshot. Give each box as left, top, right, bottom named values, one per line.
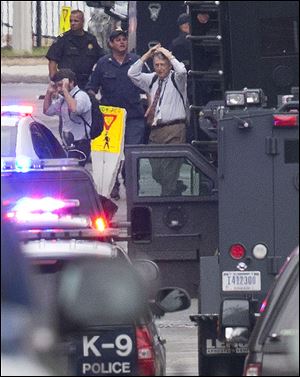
left=136, top=326, right=156, bottom=376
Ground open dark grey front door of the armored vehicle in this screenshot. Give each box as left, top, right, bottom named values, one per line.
left=125, top=144, right=218, bottom=292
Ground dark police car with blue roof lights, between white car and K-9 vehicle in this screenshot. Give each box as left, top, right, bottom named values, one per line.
left=1, top=156, right=109, bottom=224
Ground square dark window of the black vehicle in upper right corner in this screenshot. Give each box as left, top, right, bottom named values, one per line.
left=260, top=17, right=299, bottom=57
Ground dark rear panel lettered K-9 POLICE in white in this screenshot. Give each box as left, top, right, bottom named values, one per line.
left=71, top=327, right=137, bottom=376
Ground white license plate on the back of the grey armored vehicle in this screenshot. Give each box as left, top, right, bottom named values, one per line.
left=222, top=271, right=261, bottom=291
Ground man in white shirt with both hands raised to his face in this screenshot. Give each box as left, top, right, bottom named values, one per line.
left=43, top=68, right=92, bottom=166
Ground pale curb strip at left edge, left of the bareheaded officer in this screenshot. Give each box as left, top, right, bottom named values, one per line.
left=1, top=58, right=49, bottom=84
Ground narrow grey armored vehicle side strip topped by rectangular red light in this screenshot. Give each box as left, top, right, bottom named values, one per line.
left=273, top=103, right=299, bottom=260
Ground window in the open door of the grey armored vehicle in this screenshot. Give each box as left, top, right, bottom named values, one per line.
left=138, top=157, right=214, bottom=197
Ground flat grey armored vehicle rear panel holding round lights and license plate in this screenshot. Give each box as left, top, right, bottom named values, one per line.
left=218, top=109, right=291, bottom=295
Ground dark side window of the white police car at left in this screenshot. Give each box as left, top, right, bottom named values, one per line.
left=30, top=122, right=66, bottom=158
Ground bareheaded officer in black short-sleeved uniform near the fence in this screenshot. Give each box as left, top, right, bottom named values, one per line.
left=46, top=10, right=104, bottom=89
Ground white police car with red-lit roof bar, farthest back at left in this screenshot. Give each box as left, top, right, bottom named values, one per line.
left=1, top=105, right=66, bottom=159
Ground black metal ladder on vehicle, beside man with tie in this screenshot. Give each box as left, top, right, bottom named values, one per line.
left=185, top=1, right=225, bottom=138
